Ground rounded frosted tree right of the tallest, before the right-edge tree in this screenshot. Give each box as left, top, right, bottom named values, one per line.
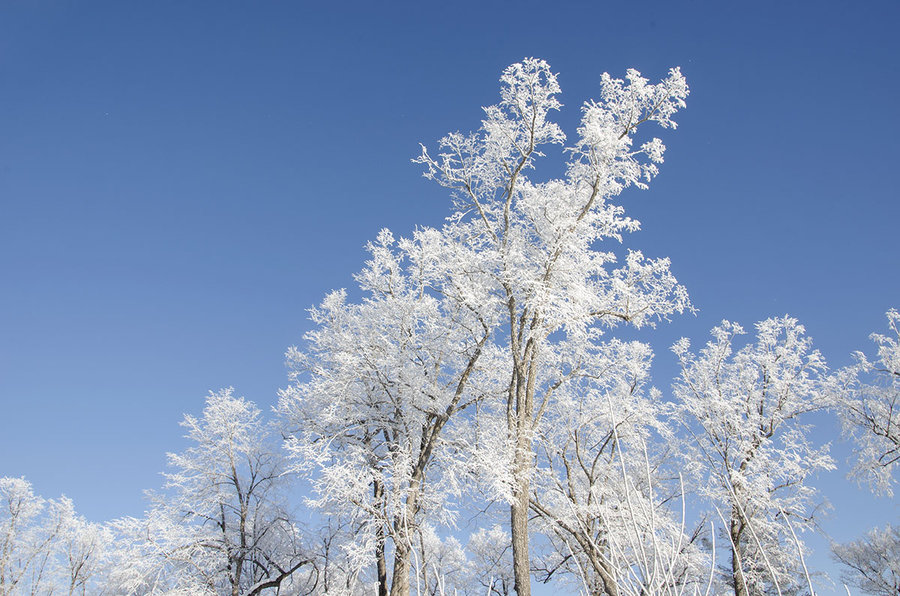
left=673, top=317, right=834, bottom=596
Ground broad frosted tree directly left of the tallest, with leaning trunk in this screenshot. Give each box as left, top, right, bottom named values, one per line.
left=278, top=230, right=490, bottom=594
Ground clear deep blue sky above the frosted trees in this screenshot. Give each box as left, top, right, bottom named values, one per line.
left=0, top=0, right=900, bottom=592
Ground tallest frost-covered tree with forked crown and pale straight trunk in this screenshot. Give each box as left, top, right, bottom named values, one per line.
left=413, top=59, right=688, bottom=596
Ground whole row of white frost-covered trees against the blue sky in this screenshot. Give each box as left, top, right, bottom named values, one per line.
left=0, top=59, right=900, bottom=596
